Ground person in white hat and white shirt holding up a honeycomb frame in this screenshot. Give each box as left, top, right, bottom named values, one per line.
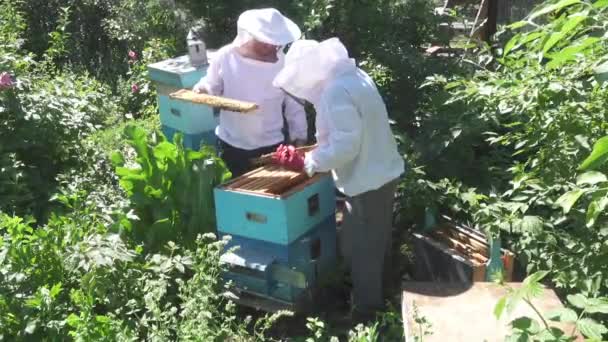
left=193, top=8, right=307, bottom=177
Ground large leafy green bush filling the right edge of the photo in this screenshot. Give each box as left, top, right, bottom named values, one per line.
left=406, top=1, right=608, bottom=310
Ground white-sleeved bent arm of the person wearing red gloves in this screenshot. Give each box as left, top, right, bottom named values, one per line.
left=304, top=87, right=363, bottom=176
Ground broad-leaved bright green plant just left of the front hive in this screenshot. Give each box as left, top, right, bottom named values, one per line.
left=112, top=125, right=230, bottom=250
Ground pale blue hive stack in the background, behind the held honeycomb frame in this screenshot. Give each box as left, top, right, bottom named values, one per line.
left=148, top=53, right=219, bottom=150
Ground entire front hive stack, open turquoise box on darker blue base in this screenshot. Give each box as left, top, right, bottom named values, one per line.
left=215, top=166, right=336, bottom=303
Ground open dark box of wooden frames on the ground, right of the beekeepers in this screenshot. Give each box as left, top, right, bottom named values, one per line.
left=413, top=223, right=515, bottom=283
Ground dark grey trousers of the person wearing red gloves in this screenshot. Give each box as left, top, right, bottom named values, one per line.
left=341, top=180, right=398, bottom=313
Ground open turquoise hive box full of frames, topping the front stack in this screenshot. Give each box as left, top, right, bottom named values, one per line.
left=214, top=165, right=336, bottom=245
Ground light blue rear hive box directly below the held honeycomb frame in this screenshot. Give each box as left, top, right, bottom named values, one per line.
left=157, top=92, right=219, bottom=134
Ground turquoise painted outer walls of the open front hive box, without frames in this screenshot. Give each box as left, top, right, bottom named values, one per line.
left=214, top=175, right=336, bottom=245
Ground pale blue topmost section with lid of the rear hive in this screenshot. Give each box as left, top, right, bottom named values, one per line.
left=148, top=55, right=208, bottom=89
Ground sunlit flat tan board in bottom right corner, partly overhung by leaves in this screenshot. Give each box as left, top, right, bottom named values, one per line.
left=401, top=282, right=583, bottom=342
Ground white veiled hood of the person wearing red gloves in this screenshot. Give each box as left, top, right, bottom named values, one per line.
left=273, top=38, right=356, bottom=104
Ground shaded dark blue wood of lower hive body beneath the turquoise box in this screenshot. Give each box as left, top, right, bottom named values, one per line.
left=223, top=215, right=337, bottom=303
